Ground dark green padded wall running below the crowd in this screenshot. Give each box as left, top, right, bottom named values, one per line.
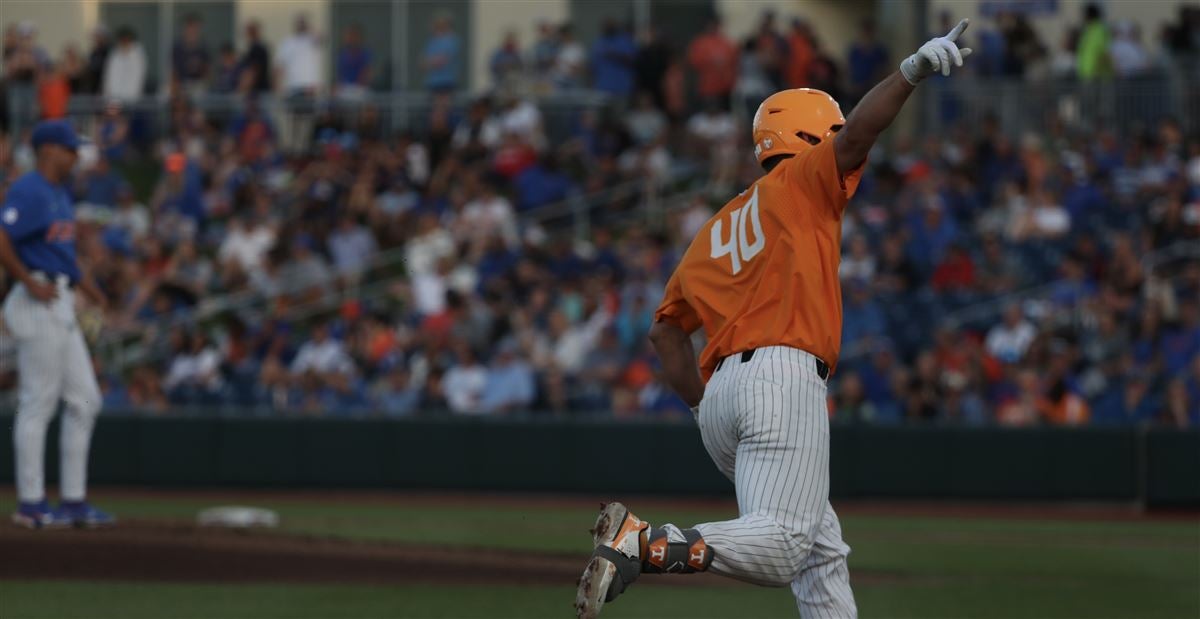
left=0, top=416, right=1200, bottom=506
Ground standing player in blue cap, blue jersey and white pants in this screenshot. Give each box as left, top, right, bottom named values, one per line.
left=0, top=121, right=113, bottom=528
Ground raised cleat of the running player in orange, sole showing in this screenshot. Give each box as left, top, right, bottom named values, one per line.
left=575, top=503, right=650, bottom=619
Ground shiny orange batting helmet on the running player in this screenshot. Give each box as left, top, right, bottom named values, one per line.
left=754, top=88, right=846, bottom=163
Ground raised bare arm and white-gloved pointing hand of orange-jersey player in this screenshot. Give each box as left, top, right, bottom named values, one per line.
left=834, top=19, right=971, bottom=174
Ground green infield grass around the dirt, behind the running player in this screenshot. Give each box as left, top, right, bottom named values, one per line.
left=0, top=493, right=1200, bottom=619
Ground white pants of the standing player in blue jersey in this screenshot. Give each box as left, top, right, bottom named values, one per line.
left=4, top=277, right=101, bottom=501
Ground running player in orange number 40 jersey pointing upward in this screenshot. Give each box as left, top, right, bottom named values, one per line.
left=575, top=19, right=971, bottom=618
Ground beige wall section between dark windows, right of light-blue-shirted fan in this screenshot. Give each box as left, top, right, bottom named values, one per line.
left=470, top=0, right=571, bottom=91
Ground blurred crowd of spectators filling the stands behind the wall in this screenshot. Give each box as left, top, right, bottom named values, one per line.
left=0, top=3, right=1200, bottom=426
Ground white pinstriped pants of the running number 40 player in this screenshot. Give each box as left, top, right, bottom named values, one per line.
left=696, top=347, right=858, bottom=619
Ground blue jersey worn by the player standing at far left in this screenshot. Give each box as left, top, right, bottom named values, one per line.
left=0, top=172, right=79, bottom=283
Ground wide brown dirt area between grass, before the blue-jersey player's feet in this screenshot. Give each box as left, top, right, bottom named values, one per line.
left=0, top=521, right=737, bottom=585
